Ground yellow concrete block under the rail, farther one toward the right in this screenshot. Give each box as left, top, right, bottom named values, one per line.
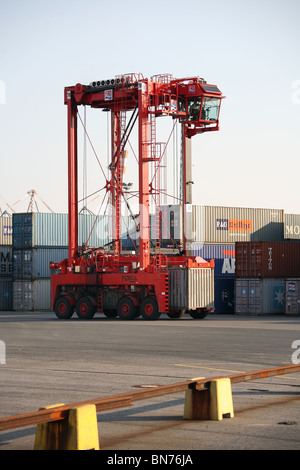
left=183, top=378, right=234, bottom=421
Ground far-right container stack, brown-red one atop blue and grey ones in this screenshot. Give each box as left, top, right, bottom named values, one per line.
left=235, top=241, right=300, bottom=314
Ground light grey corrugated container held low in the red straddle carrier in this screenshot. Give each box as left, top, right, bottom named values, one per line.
left=169, top=268, right=214, bottom=309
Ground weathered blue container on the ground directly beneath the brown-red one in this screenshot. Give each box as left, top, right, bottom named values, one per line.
left=235, top=278, right=285, bottom=315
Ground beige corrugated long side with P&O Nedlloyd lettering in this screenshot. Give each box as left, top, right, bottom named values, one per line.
left=186, top=205, right=284, bottom=243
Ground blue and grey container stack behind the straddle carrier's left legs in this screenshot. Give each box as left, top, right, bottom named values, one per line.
left=12, top=213, right=136, bottom=310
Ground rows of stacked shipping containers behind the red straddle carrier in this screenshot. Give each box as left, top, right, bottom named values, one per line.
left=0, top=205, right=300, bottom=315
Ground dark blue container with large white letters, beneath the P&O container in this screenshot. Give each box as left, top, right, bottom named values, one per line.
left=192, top=244, right=235, bottom=278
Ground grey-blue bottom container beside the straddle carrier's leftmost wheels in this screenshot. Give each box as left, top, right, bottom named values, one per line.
left=13, top=279, right=51, bottom=311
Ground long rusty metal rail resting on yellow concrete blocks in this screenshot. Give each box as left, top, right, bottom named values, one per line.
left=0, top=364, right=300, bottom=431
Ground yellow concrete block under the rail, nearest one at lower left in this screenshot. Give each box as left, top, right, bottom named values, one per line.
left=34, top=403, right=100, bottom=450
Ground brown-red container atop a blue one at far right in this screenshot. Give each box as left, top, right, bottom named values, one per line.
left=235, top=242, right=300, bottom=278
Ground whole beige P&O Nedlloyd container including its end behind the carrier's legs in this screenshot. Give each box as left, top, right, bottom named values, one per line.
left=150, top=204, right=284, bottom=247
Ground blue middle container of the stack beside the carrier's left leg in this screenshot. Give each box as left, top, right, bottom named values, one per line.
left=12, top=247, right=68, bottom=280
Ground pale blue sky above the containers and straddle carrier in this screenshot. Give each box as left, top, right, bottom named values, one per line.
left=0, top=0, right=300, bottom=214
